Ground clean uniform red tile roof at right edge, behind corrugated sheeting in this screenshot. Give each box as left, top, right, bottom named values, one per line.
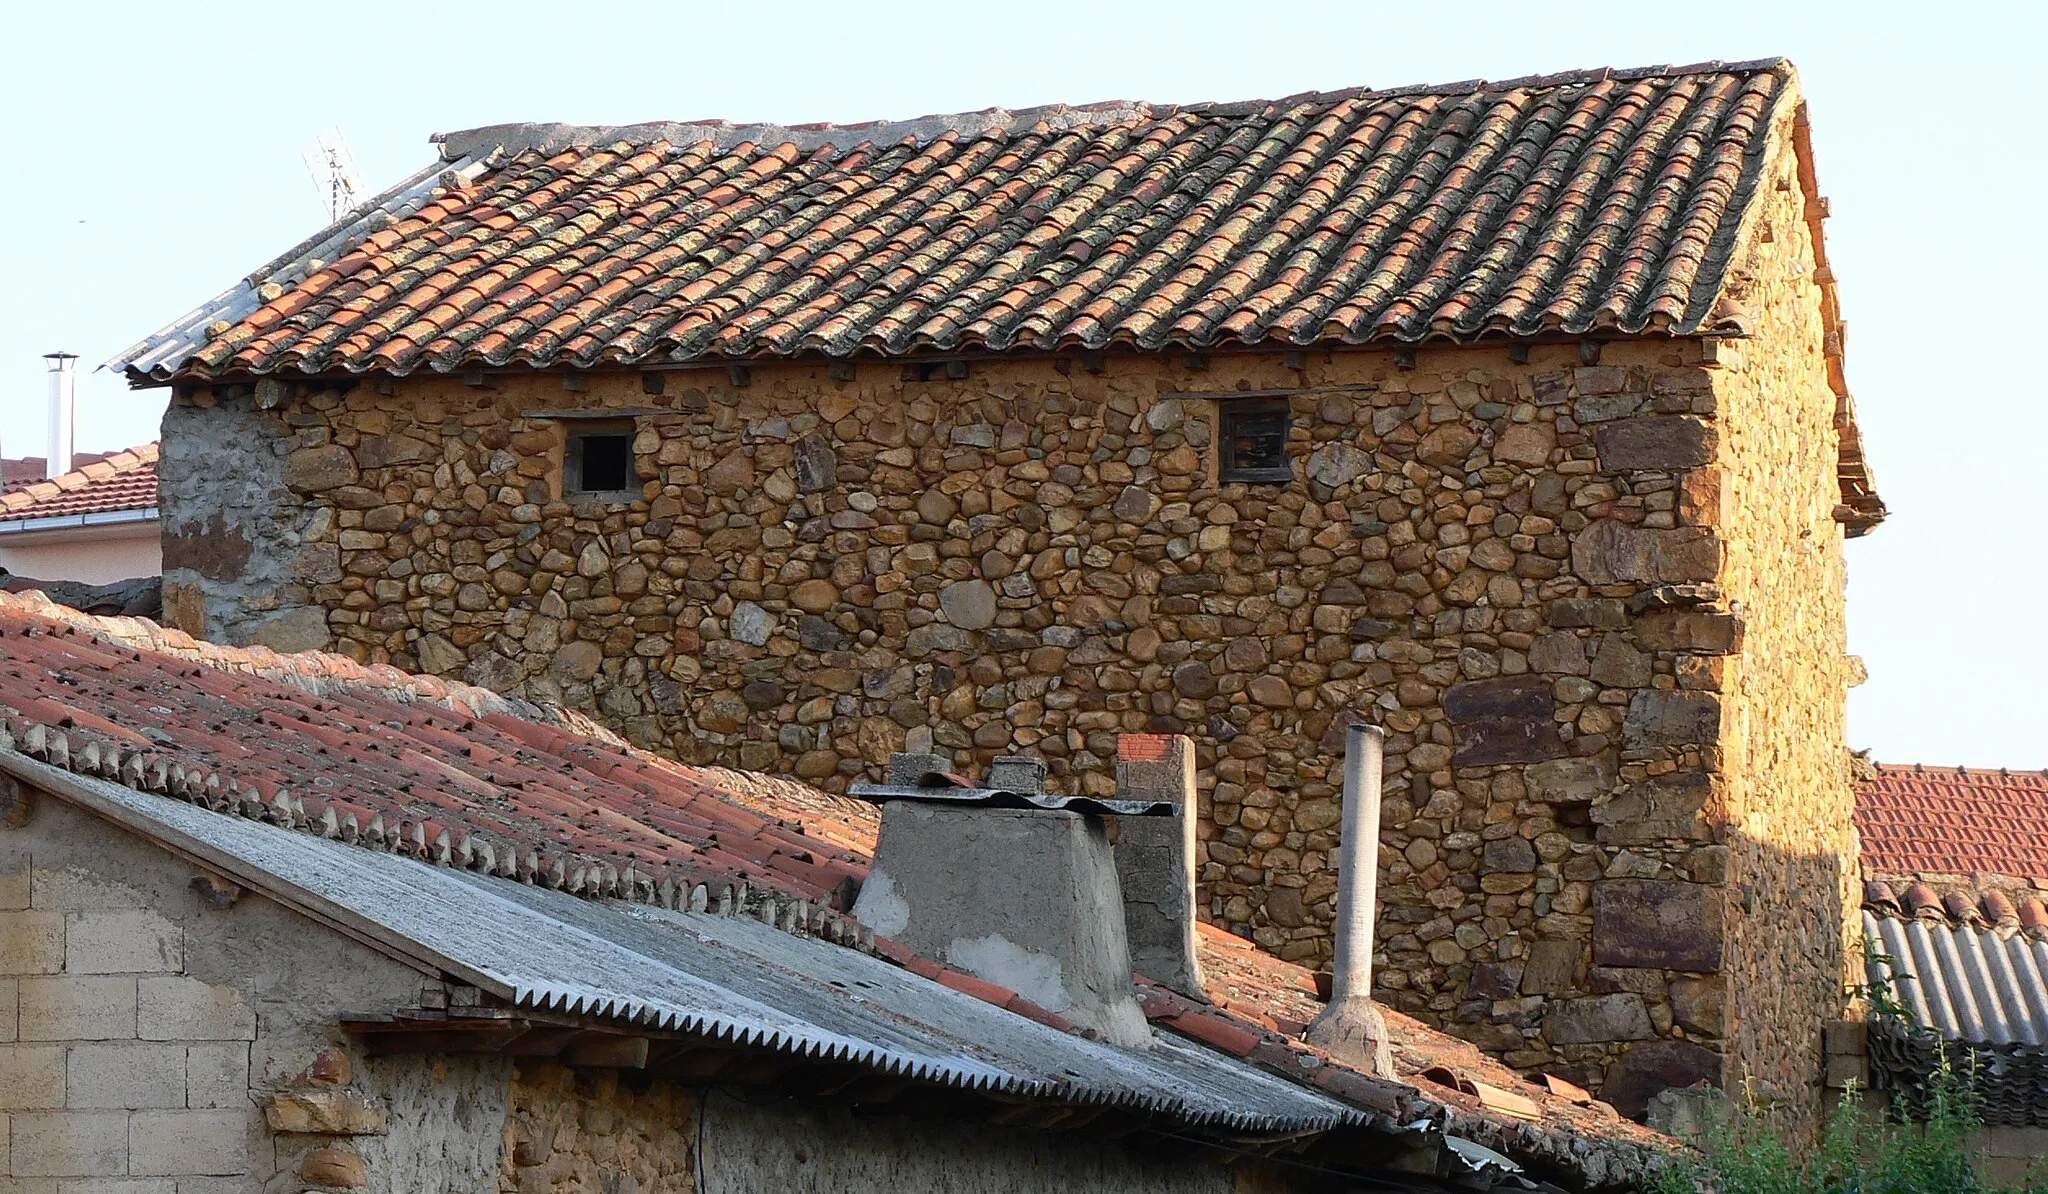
left=1855, top=764, right=2048, bottom=879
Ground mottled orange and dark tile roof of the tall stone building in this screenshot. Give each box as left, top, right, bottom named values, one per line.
left=127, top=59, right=1796, bottom=377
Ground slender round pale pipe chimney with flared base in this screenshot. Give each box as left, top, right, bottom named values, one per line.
left=1309, top=723, right=1393, bottom=1077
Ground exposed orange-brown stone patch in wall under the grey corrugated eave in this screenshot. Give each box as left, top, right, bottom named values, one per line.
left=498, top=1063, right=696, bottom=1194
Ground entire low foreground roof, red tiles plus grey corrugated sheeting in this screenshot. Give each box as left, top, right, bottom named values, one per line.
left=0, top=596, right=1659, bottom=1188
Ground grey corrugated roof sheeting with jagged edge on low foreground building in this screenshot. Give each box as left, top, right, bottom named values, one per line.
left=59, top=756, right=1372, bottom=1135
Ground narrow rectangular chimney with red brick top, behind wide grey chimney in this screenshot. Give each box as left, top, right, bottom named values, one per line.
left=1116, top=733, right=1208, bottom=1004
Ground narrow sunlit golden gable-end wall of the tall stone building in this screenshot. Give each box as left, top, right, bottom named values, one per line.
left=1716, top=113, right=1862, bottom=1126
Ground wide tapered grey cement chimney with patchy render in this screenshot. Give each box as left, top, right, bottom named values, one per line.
left=854, top=756, right=1163, bottom=1049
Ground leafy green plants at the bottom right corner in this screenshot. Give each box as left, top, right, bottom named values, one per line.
left=1649, top=1053, right=2048, bottom=1194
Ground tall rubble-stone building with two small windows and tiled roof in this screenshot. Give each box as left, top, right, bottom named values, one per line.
left=117, top=59, right=1884, bottom=1110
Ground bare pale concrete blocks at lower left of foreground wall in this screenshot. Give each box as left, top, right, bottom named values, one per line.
left=0, top=843, right=256, bottom=1194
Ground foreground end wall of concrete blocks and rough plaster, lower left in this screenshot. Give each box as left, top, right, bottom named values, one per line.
left=0, top=797, right=510, bottom=1194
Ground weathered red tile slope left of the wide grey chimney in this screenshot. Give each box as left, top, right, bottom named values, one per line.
left=0, top=594, right=866, bottom=901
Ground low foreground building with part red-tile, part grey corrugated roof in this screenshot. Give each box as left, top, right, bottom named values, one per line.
left=0, top=596, right=1667, bottom=1194
